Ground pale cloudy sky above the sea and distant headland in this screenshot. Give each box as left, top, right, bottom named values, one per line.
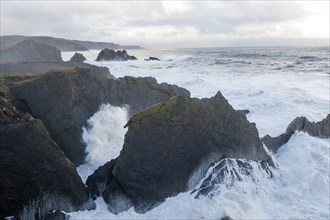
left=0, top=0, right=330, bottom=48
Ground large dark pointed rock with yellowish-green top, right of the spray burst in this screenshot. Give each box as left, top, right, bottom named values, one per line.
left=89, top=92, right=271, bottom=213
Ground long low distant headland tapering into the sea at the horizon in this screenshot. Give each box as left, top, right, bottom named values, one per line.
left=0, top=35, right=142, bottom=51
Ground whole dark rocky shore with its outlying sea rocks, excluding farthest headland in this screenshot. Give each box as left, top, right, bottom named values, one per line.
left=0, top=37, right=330, bottom=219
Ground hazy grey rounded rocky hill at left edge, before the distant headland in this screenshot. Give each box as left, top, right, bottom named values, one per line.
left=0, top=40, right=63, bottom=63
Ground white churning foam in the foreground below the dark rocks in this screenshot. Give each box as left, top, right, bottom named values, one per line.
left=70, top=132, right=330, bottom=219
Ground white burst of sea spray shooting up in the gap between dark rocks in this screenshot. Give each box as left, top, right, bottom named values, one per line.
left=77, top=104, right=128, bottom=182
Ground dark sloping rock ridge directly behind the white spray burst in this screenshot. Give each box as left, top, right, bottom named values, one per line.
left=9, top=68, right=190, bottom=165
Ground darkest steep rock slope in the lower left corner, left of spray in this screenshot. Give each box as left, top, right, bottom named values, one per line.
left=0, top=97, right=93, bottom=219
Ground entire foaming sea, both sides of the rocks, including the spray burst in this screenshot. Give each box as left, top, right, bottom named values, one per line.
left=62, top=47, right=330, bottom=219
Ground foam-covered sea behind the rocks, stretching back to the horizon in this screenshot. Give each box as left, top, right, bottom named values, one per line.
left=62, top=48, right=330, bottom=136
